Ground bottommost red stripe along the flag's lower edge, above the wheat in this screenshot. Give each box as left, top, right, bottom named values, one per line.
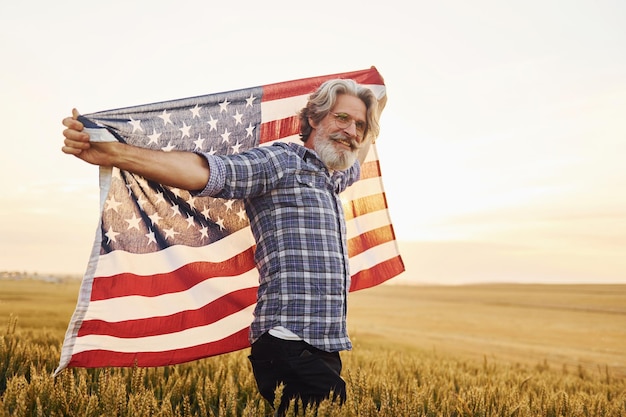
left=68, top=328, right=250, bottom=368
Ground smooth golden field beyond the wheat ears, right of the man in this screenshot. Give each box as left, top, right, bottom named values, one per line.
left=349, top=284, right=626, bottom=377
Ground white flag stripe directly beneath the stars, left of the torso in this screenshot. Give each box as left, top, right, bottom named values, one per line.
left=95, top=227, right=254, bottom=277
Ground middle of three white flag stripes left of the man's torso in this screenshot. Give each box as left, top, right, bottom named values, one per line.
left=84, top=268, right=259, bottom=323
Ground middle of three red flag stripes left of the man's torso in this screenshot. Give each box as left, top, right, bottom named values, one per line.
left=78, top=287, right=257, bottom=338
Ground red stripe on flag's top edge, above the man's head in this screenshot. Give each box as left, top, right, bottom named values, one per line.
left=262, top=67, right=384, bottom=101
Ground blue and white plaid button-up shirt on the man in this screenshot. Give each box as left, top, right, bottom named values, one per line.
left=200, top=143, right=360, bottom=352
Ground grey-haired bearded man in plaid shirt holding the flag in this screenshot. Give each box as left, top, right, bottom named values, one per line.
left=62, top=80, right=379, bottom=414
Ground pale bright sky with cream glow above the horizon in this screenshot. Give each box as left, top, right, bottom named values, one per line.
left=0, top=0, right=626, bottom=285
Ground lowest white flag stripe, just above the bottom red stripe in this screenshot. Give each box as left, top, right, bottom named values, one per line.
left=72, top=305, right=254, bottom=354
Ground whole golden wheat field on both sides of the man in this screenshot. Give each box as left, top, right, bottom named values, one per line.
left=0, top=280, right=626, bottom=417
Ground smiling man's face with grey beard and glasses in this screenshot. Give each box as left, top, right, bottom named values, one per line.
left=305, top=94, right=367, bottom=171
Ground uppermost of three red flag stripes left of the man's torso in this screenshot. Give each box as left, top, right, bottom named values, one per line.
left=91, top=248, right=255, bottom=301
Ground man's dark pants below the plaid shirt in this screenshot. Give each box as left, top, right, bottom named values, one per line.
left=248, top=333, right=346, bottom=415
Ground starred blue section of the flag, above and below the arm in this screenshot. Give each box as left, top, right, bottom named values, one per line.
left=100, top=90, right=261, bottom=253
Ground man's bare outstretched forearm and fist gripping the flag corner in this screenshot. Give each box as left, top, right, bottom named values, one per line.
left=61, top=109, right=210, bottom=191
